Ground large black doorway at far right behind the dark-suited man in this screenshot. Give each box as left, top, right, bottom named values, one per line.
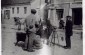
left=72, top=8, right=82, bottom=25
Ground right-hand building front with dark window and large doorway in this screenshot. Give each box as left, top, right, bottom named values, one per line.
left=48, top=0, right=82, bottom=27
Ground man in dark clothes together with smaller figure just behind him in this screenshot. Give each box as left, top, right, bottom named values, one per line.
left=59, top=16, right=73, bottom=49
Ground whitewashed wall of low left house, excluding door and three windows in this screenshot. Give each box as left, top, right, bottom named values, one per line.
left=2, top=5, right=31, bottom=18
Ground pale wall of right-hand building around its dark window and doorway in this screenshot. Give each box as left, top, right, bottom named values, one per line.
left=49, top=0, right=82, bottom=26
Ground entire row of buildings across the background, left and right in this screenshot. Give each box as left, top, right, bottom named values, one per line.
left=1, top=0, right=82, bottom=27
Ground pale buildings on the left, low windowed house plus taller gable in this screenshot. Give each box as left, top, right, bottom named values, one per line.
left=1, top=0, right=46, bottom=20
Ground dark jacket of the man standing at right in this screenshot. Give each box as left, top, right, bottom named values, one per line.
left=65, top=20, right=73, bottom=36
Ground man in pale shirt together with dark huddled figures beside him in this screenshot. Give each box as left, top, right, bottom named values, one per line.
left=23, top=9, right=52, bottom=52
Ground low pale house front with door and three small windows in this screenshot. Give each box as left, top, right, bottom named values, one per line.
left=2, top=4, right=30, bottom=19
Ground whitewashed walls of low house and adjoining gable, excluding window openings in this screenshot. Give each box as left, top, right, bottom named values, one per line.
left=2, top=0, right=45, bottom=21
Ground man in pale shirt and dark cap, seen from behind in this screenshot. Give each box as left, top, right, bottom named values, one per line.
left=25, top=9, right=36, bottom=52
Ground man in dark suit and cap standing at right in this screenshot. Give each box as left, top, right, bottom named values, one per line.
left=64, top=16, right=73, bottom=49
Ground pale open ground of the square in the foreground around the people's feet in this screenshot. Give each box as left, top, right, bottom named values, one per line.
left=2, top=24, right=83, bottom=55
